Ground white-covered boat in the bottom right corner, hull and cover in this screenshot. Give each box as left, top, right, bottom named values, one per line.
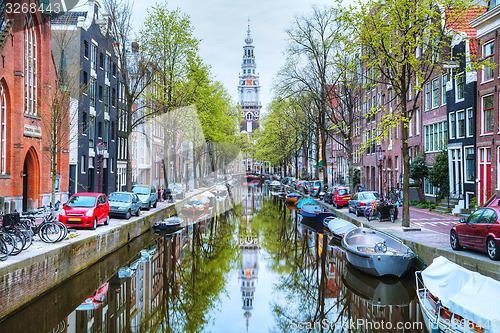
left=415, top=257, right=500, bottom=333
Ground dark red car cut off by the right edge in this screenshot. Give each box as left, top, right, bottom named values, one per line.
left=450, top=207, right=500, bottom=260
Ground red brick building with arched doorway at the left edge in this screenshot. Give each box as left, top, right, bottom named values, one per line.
left=0, top=0, right=68, bottom=211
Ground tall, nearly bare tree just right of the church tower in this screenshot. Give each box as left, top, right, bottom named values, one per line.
left=278, top=7, right=343, bottom=184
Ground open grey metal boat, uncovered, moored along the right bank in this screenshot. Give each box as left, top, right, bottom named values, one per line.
left=342, top=228, right=414, bottom=277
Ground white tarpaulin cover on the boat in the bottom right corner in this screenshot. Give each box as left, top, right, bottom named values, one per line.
left=422, top=257, right=500, bottom=332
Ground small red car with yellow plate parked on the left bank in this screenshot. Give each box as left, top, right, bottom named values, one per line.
left=59, top=193, right=109, bottom=230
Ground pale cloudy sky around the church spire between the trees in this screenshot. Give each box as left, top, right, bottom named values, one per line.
left=129, top=0, right=340, bottom=115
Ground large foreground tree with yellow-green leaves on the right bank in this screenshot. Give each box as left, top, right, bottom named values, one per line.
left=348, top=0, right=471, bottom=226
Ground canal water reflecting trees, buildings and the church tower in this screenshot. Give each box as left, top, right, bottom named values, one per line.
left=0, top=185, right=424, bottom=333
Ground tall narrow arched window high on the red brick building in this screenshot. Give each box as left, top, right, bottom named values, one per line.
left=24, top=13, right=38, bottom=115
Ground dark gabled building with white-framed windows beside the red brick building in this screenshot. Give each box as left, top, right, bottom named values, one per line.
left=52, top=0, right=120, bottom=194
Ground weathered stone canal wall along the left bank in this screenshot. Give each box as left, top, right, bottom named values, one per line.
left=0, top=199, right=181, bottom=319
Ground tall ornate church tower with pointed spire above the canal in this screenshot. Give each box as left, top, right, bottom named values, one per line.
left=238, top=19, right=262, bottom=133
